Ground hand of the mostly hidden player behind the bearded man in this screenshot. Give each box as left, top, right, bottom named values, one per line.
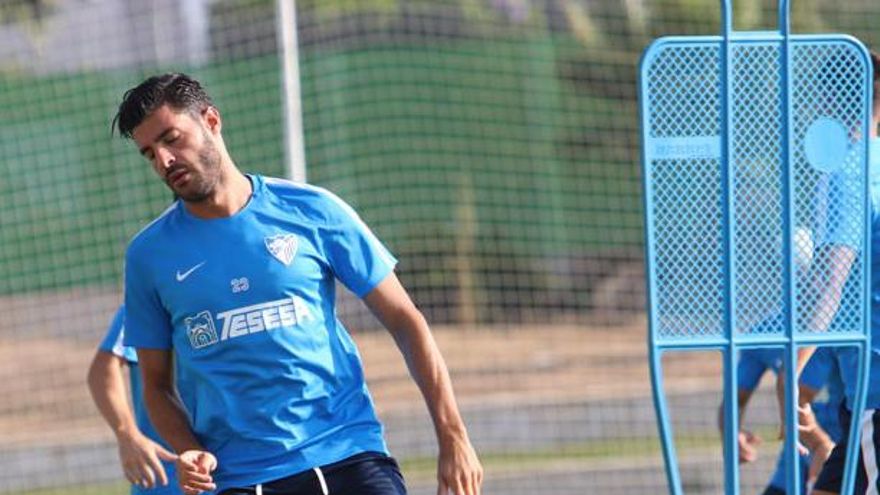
left=117, top=431, right=177, bottom=489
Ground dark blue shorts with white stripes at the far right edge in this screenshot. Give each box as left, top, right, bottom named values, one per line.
left=813, top=406, right=880, bottom=495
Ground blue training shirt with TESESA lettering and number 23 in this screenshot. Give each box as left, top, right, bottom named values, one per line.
left=125, top=175, right=396, bottom=492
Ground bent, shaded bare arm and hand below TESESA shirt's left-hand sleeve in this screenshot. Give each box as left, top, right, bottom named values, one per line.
left=137, top=349, right=217, bottom=495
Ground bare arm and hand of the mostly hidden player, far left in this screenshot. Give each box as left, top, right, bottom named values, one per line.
left=87, top=351, right=176, bottom=488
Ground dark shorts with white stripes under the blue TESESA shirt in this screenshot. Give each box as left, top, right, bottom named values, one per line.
left=220, top=452, right=406, bottom=495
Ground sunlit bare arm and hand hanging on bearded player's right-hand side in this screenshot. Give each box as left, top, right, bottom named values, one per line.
left=364, top=273, right=483, bottom=495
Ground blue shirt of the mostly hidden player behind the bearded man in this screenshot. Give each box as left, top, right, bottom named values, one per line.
left=98, top=305, right=183, bottom=495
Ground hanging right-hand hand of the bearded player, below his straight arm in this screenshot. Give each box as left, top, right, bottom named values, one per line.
left=437, top=438, right=483, bottom=495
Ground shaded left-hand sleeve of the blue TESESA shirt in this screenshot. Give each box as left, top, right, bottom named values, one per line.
left=124, top=247, right=172, bottom=349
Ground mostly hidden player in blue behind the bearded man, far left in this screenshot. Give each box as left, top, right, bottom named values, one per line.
left=88, top=306, right=181, bottom=495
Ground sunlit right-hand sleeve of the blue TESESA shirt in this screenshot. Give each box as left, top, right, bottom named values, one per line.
left=323, top=192, right=397, bottom=298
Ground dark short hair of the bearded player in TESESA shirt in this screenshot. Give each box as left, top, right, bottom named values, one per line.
left=111, top=73, right=214, bottom=138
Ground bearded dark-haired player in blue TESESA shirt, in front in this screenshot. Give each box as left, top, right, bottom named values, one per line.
left=115, top=74, right=482, bottom=495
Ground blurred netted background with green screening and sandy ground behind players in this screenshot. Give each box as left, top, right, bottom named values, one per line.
left=0, top=0, right=880, bottom=495
